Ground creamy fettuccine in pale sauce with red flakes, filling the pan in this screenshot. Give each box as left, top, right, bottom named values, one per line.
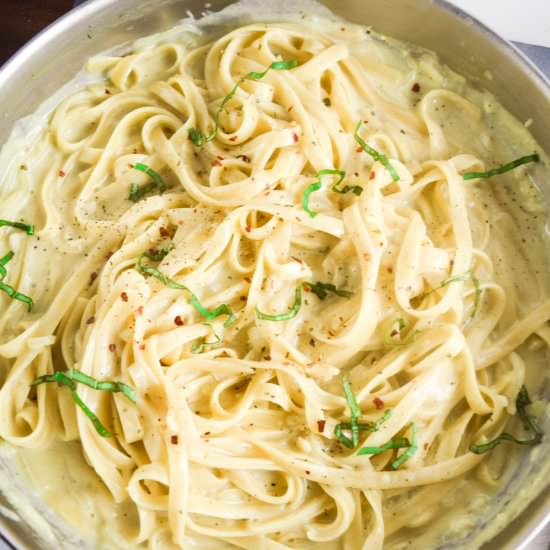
left=0, top=7, right=550, bottom=550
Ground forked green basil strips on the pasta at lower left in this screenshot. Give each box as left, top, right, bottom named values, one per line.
left=31, top=369, right=136, bottom=437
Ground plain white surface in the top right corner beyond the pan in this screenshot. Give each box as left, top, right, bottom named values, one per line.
left=449, top=0, right=550, bottom=48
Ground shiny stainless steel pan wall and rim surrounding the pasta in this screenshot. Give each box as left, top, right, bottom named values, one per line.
left=0, top=0, right=550, bottom=550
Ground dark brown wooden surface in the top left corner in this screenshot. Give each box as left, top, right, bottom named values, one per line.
left=0, top=0, right=73, bottom=65
